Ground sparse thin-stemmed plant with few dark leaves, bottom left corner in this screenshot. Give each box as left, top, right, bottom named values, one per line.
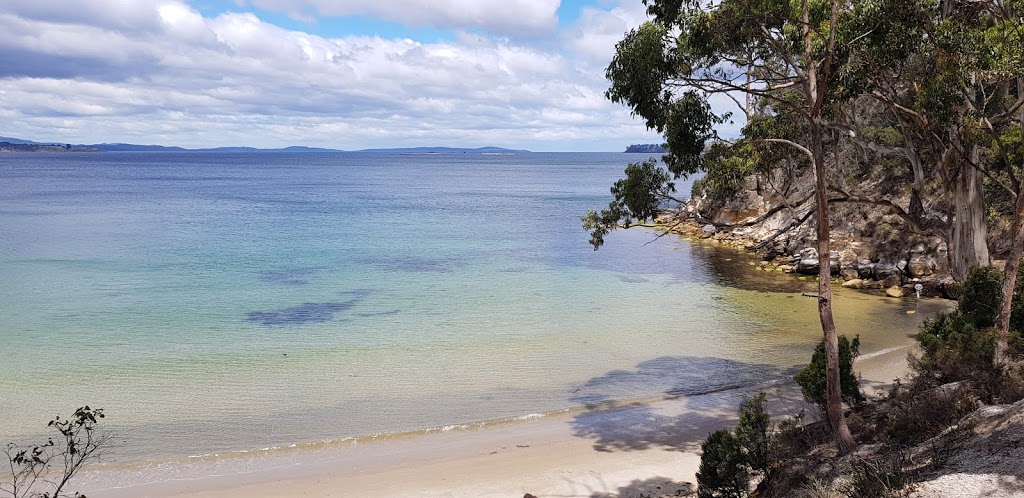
left=0, top=406, right=110, bottom=498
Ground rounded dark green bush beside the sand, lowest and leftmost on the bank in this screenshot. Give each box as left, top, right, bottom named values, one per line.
left=697, top=429, right=751, bottom=498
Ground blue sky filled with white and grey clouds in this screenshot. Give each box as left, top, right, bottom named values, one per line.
left=0, top=0, right=712, bottom=152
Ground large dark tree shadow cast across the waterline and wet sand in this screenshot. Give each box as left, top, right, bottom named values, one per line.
left=570, top=357, right=798, bottom=452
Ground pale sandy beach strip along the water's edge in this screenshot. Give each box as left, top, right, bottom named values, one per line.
left=75, top=343, right=912, bottom=498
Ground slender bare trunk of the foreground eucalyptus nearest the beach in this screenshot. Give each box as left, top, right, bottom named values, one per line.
left=810, top=123, right=856, bottom=455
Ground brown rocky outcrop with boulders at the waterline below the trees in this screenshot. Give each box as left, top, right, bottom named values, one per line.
left=663, top=172, right=955, bottom=298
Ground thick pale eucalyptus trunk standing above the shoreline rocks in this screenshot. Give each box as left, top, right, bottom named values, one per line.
left=949, top=154, right=990, bottom=281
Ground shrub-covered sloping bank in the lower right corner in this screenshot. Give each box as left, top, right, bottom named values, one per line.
left=697, top=268, right=1024, bottom=498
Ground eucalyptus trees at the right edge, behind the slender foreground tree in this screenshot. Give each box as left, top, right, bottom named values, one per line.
left=843, top=0, right=1024, bottom=364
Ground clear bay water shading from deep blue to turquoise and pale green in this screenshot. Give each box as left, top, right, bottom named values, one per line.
left=0, top=153, right=942, bottom=461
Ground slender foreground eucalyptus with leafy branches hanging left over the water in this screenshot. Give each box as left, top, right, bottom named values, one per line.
left=584, top=0, right=854, bottom=454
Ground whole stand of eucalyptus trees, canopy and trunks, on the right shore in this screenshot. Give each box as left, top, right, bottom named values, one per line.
left=583, top=0, right=1024, bottom=454
